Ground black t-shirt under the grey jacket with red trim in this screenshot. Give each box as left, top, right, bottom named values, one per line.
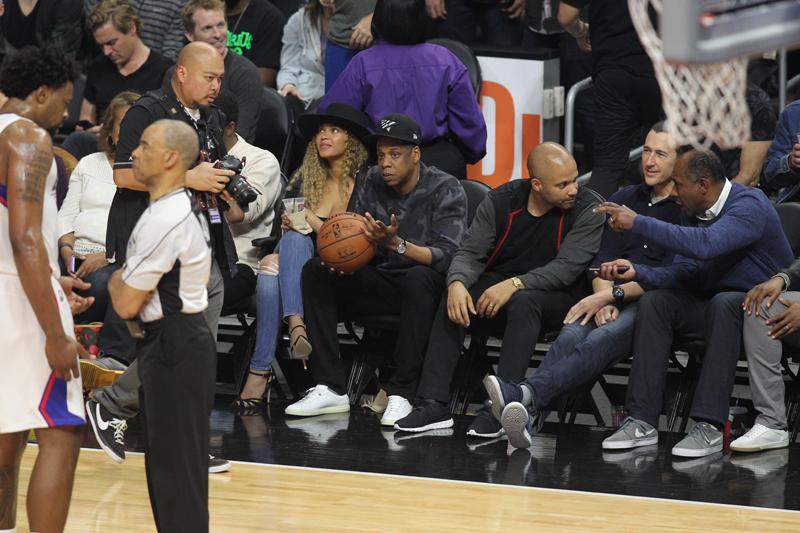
left=491, top=208, right=564, bottom=278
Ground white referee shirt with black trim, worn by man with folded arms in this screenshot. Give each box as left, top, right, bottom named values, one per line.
left=122, top=189, right=211, bottom=322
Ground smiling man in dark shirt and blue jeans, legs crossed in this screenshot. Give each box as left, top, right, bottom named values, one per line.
left=483, top=122, right=681, bottom=448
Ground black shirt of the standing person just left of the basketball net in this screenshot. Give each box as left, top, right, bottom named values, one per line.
left=561, top=0, right=655, bottom=77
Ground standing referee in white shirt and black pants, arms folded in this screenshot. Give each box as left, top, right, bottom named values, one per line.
left=108, top=119, right=215, bottom=533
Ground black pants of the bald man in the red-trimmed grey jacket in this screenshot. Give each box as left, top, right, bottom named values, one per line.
left=417, top=272, right=577, bottom=402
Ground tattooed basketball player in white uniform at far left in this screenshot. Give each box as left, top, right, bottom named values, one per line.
left=0, top=47, right=84, bottom=532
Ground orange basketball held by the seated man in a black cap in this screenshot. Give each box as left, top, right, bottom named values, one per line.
left=317, top=213, right=375, bottom=273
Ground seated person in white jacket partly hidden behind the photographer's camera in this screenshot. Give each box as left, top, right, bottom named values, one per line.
left=215, top=94, right=281, bottom=307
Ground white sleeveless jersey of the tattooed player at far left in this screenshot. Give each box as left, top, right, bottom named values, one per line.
left=0, top=113, right=60, bottom=276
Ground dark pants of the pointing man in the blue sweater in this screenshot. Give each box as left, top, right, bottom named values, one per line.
left=626, top=290, right=744, bottom=427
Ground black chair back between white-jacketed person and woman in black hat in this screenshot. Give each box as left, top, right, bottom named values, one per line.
left=253, top=87, right=294, bottom=172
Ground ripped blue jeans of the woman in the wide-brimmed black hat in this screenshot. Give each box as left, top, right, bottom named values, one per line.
left=250, top=231, right=314, bottom=372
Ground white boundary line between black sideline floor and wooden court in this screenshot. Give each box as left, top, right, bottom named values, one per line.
left=67, top=443, right=800, bottom=515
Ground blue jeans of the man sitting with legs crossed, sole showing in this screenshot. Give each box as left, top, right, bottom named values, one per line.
left=526, top=302, right=639, bottom=412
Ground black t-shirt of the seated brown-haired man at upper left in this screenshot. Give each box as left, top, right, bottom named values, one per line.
left=83, top=50, right=172, bottom=124
